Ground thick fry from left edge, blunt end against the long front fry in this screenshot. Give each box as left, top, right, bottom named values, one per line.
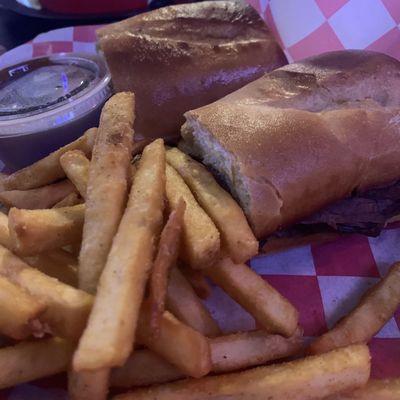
left=0, top=246, right=93, bottom=340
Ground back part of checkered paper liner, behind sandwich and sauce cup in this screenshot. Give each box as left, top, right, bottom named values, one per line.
left=0, top=0, right=400, bottom=68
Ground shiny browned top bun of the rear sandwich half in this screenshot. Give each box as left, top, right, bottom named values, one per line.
left=97, top=1, right=286, bottom=142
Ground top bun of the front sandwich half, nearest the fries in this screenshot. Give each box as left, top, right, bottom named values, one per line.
left=182, top=51, right=400, bottom=237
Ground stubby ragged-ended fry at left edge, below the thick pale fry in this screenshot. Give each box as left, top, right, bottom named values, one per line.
left=0, top=276, right=46, bottom=340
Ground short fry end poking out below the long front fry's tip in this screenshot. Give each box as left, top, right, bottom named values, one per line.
left=68, top=368, right=110, bottom=400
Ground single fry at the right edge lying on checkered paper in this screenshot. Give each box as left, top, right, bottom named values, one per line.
left=310, top=263, right=400, bottom=354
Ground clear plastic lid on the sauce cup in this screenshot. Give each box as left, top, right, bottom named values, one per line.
left=0, top=53, right=111, bottom=136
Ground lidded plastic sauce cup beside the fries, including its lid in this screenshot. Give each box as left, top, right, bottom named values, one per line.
left=0, top=53, right=112, bottom=172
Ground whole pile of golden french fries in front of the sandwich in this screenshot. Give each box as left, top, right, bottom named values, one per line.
left=0, top=93, right=400, bottom=400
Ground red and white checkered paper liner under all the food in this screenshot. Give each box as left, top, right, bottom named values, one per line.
left=0, top=8, right=400, bottom=400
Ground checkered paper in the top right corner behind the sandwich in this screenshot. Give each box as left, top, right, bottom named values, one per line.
left=248, top=0, right=400, bottom=62
